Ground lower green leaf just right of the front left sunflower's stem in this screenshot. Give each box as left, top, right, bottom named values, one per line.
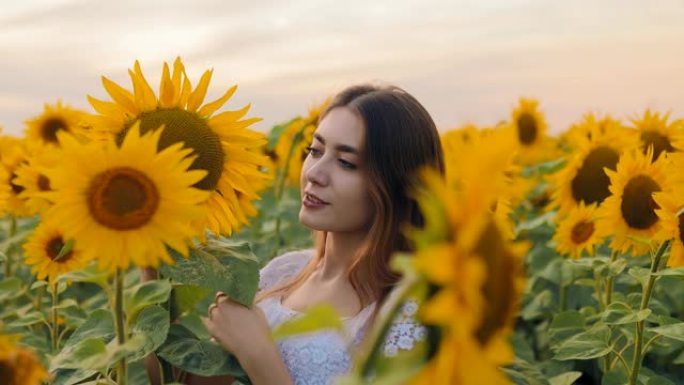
left=122, top=305, right=170, bottom=362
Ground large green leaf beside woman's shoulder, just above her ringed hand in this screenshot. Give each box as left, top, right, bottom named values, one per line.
left=161, top=239, right=259, bottom=306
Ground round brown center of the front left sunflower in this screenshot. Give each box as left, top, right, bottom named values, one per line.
left=88, top=167, right=159, bottom=230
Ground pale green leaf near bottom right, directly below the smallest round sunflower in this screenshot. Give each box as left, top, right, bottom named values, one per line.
left=554, top=324, right=612, bottom=361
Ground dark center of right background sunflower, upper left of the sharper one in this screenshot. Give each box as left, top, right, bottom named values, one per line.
left=570, top=146, right=620, bottom=204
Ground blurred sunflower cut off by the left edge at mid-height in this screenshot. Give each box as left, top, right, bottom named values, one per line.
left=0, top=136, right=31, bottom=217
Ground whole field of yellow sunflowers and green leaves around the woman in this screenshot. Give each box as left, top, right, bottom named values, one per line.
left=0, top=58, right=684, bottom=385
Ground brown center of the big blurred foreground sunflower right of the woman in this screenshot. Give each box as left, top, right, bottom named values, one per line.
left=474, top=221, right=517, bottom=345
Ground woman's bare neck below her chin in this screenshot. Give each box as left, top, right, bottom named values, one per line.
left=317, top=228, right=366, bottom=280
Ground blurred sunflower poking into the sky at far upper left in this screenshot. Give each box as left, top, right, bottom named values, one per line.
left=26, top=101, right=85, bottom=146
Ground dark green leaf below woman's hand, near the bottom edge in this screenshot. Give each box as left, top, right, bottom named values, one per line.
left=157, top=324, right=245, bottom=377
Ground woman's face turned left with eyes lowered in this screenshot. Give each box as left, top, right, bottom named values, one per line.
left=299, top=107, right=374, bottom=232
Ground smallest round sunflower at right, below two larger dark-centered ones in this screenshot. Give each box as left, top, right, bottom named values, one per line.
left=553, top=202, right=603, bottom=258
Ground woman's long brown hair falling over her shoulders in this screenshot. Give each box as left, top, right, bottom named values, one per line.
left=258, top=84, right=444, bottom=306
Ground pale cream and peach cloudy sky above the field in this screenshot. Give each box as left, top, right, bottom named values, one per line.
left=0, top=0, right=684, bottom=135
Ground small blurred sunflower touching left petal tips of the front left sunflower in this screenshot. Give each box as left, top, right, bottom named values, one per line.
left=14, top=147, right=61, bottom=214
